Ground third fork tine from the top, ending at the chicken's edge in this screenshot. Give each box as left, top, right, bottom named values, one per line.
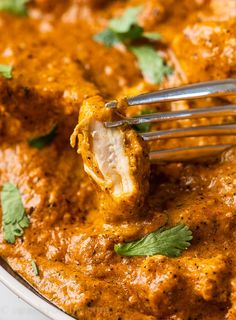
left=140, top=124, right=236, bottom=141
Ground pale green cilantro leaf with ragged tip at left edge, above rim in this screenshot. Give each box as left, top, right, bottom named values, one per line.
left=1, top=183, right=29, bottom=243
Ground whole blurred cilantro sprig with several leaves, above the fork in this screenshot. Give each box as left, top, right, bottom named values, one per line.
left=94, top=6, right=172, bottom=84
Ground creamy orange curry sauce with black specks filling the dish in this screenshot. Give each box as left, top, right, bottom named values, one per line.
left=0, top=0, right=236, bottom=320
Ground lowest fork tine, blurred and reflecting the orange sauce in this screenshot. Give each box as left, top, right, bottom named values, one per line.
left=149, top=144, right=235, bottom=163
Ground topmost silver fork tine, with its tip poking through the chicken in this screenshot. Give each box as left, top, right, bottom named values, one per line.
left=105, top=79, right=236, bottom=109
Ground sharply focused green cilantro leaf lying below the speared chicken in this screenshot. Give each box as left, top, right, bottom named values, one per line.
left=114, top=224, right=192, bottom=257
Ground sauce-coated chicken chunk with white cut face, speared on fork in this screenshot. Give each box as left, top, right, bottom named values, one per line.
left=71, top=96, right=149, bottom=221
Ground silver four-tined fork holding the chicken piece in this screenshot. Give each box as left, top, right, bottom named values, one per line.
left=104, top=79, right=236, bottom=162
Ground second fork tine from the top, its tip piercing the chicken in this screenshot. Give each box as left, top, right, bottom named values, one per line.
left=104, top=104, right=236, bottom=128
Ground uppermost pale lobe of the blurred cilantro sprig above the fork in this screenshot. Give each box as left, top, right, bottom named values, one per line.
left=109, top=6, right=142, bottom=33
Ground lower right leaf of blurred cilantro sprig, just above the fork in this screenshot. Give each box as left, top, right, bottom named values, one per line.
left=131, top=45, right=172, bottom=84
